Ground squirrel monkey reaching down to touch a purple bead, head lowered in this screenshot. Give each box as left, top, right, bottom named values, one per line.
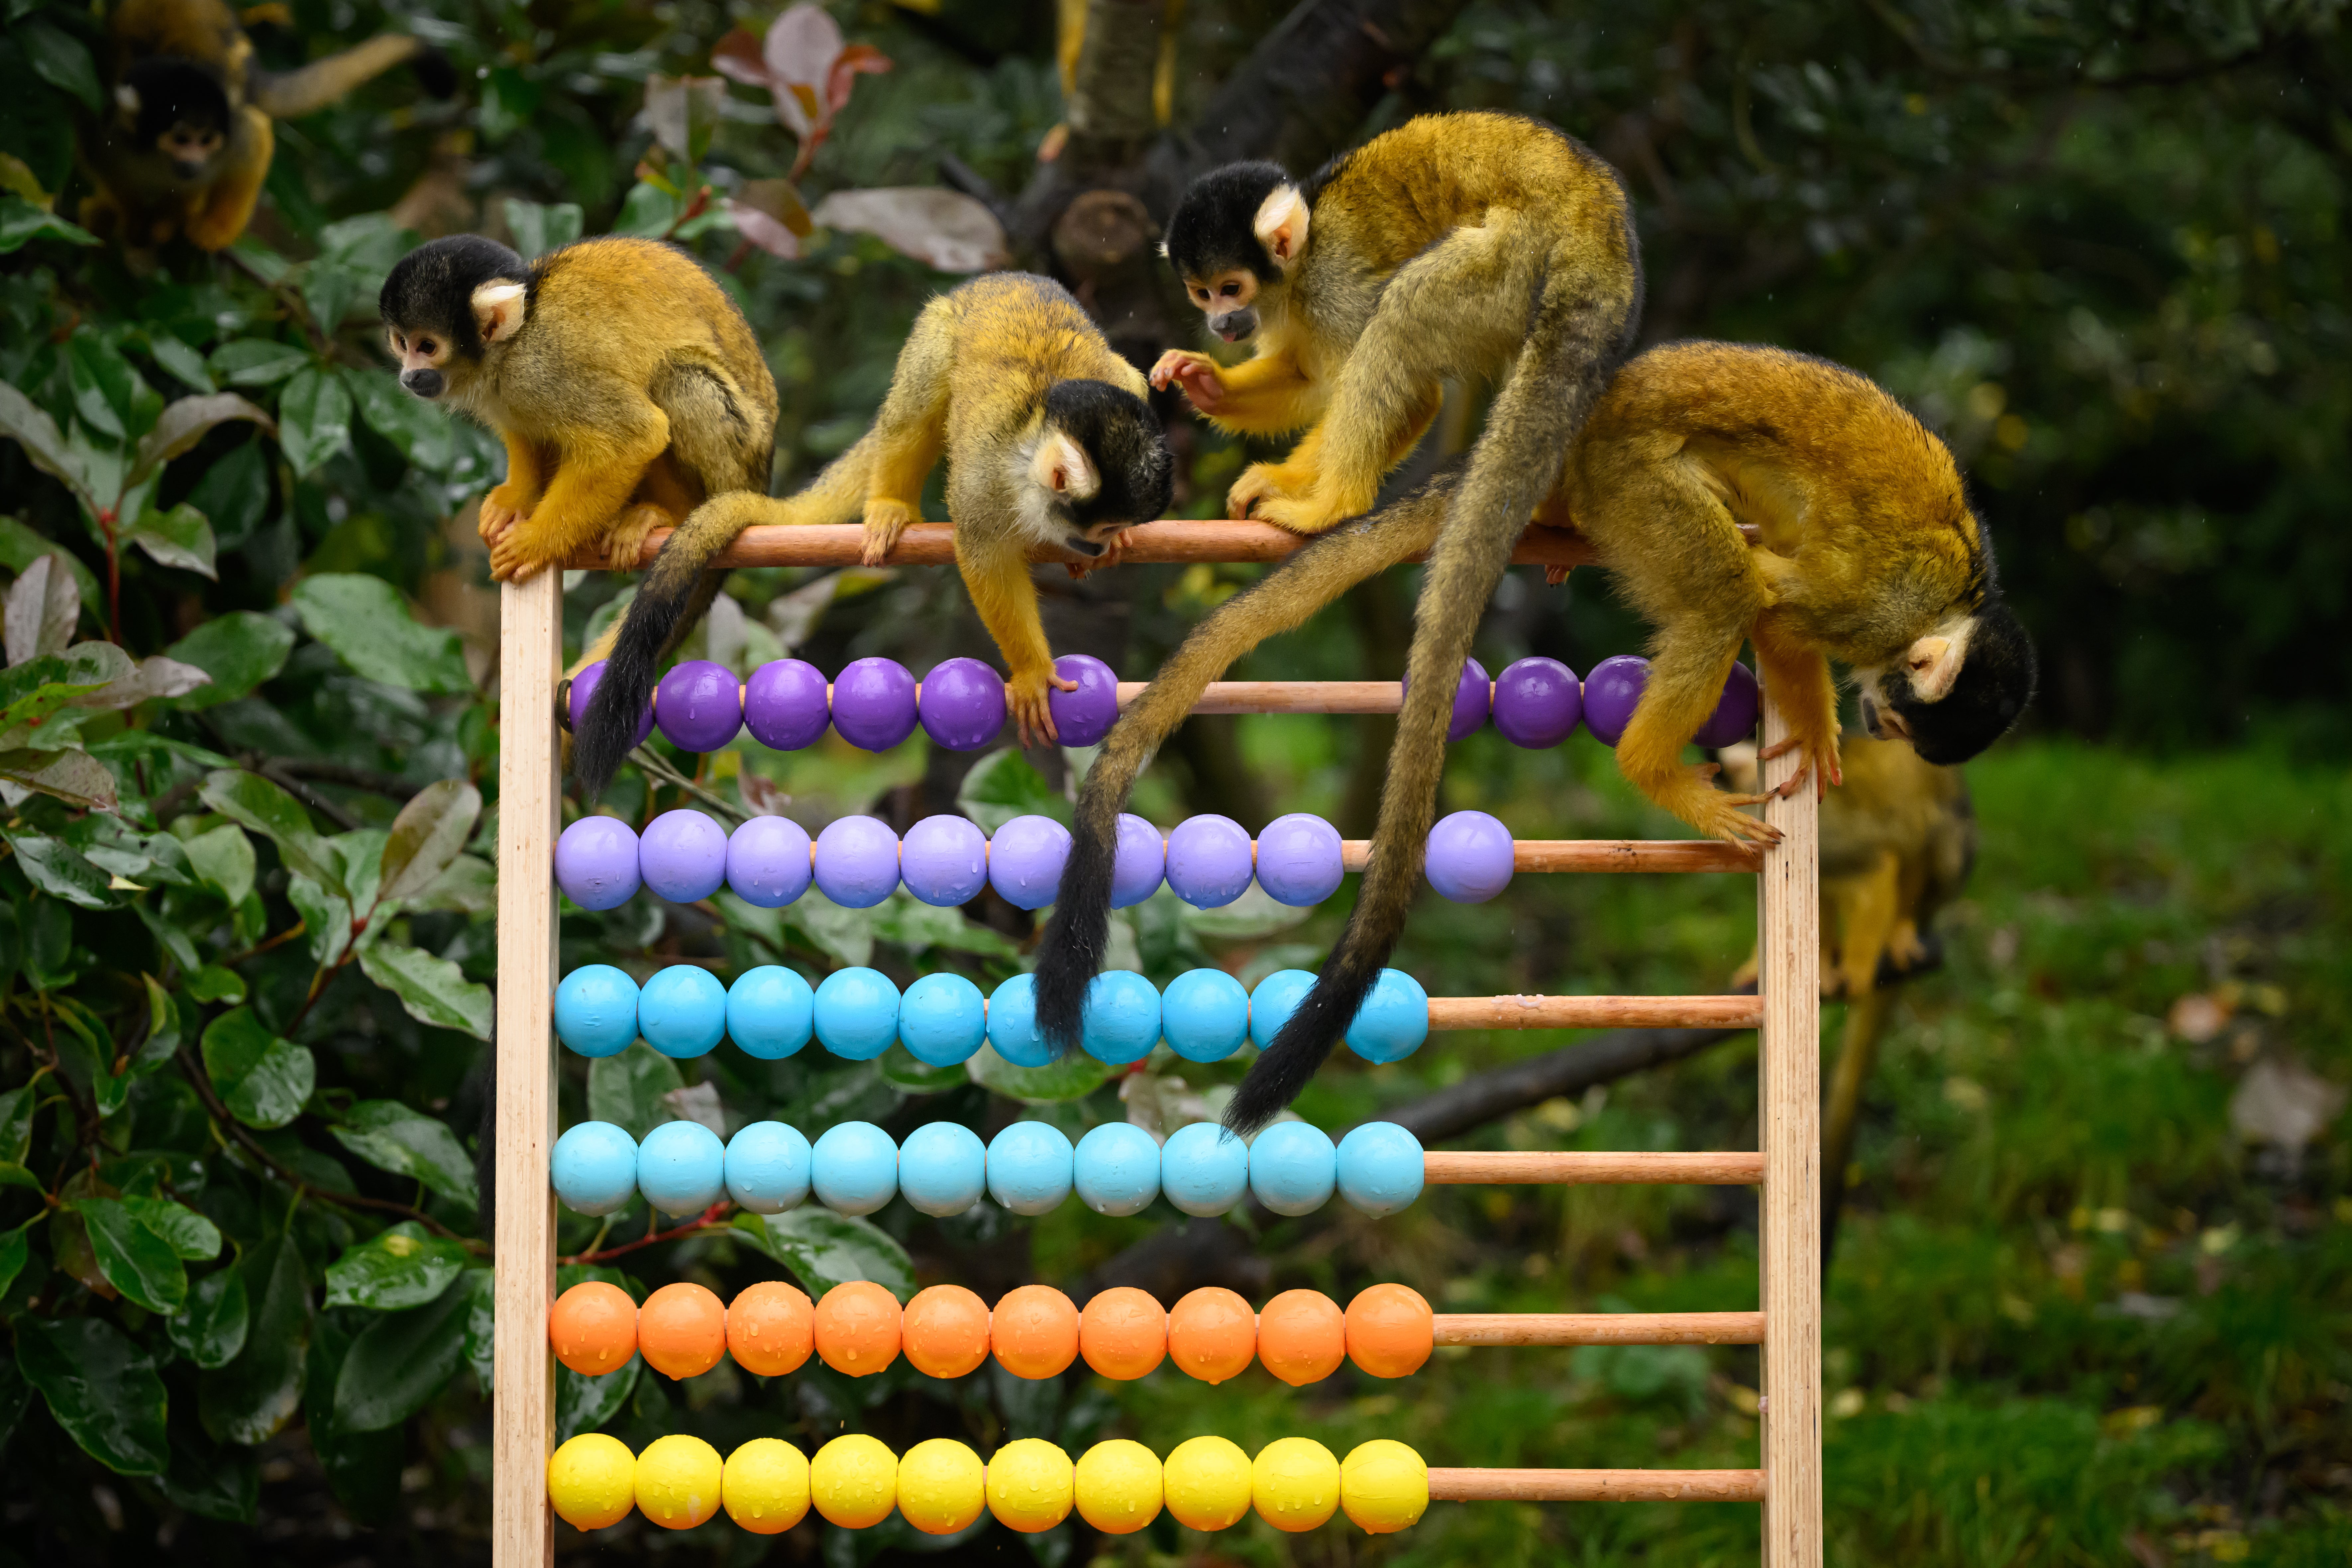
left=572, top=273, right=1174, bottom=799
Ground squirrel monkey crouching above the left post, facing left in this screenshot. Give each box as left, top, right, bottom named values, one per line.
left=379, top=235, right=776, bottom=583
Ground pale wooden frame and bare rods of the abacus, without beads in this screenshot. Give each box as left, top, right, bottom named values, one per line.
left=491, top=522, right=1823, bottom=1568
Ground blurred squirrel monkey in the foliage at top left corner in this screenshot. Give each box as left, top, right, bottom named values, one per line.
left=80, top=0, right=456, bottom=252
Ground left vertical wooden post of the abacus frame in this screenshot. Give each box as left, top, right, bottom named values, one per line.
left=489, top=571, right=565, bottom=1568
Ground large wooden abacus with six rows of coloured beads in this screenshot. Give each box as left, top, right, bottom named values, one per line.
left=491, top=522, right=1823, bottom=1568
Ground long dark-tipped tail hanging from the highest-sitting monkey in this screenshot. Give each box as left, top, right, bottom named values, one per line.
left=1226, top=252, right=1637, bottom=1135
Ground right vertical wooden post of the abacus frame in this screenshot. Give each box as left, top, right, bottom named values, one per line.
left=1757, top=684, right=1823, bottom=1568
